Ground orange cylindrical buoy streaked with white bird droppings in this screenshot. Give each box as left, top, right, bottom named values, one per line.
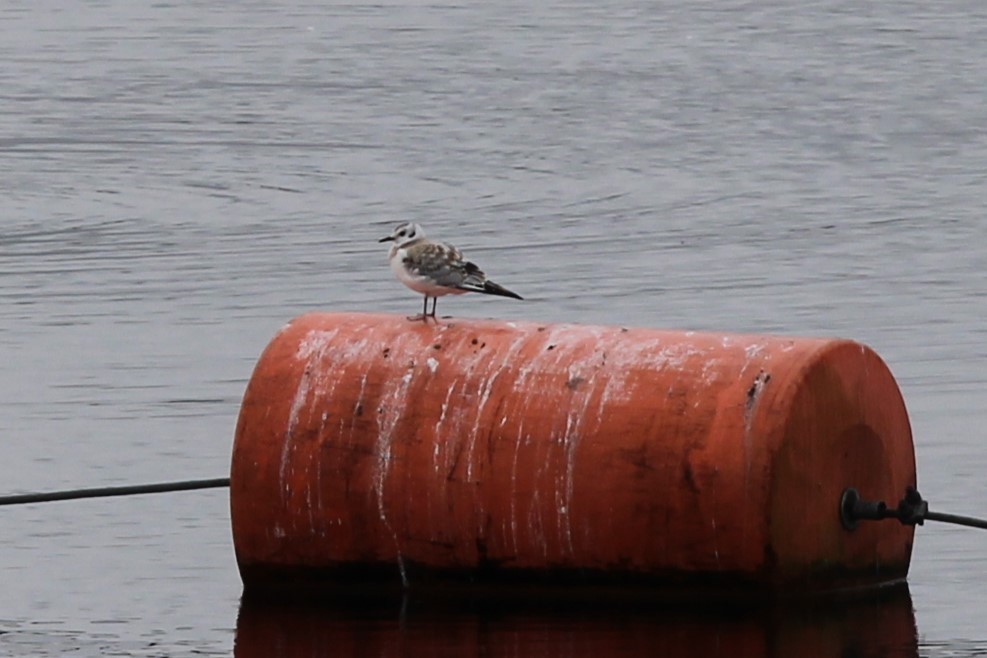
left=231, top=313, right=916, bottom=592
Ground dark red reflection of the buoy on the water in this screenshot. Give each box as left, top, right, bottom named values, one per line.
left=234, top=585, right=919, bottom=658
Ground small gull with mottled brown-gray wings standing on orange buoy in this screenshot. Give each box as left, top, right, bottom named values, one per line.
left=378, top=222, right=524, bottom=321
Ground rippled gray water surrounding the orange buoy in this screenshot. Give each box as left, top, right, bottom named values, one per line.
left=0, top=0, right=987, bottom=656
